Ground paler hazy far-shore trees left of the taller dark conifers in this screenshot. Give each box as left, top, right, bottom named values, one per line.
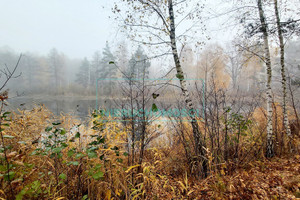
left=0, top=48, right=78, bottom=96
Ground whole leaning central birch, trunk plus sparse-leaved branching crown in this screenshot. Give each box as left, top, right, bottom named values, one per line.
left=113, top=0, right=207, bottom=176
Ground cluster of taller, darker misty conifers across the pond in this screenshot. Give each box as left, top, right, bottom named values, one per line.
left=75, top=43, right=151, bottom=95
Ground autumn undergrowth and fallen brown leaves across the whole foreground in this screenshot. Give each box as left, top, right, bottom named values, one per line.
left=0, top=107, right=300, bottom=200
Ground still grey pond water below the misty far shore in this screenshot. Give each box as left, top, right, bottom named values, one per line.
left=6, top=96, right=202, bottom=120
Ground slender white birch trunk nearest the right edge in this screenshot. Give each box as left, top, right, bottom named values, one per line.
left=274, top=0, right=292, bottom=150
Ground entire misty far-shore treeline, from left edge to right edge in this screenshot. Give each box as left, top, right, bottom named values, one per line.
left=0, top=40, right=300, bottom=96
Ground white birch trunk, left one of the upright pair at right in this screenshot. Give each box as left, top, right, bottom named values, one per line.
left=257, top=0, right=274, bottom=158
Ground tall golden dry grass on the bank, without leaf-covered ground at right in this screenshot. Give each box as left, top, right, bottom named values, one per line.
left=0, top=107, right=299, bottom=200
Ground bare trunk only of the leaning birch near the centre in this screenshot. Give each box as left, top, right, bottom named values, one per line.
left=168, top=0, right=207, bottom=177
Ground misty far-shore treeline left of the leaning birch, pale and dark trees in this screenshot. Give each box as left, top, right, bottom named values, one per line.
left=0, top=43, right=151, bottom=96
